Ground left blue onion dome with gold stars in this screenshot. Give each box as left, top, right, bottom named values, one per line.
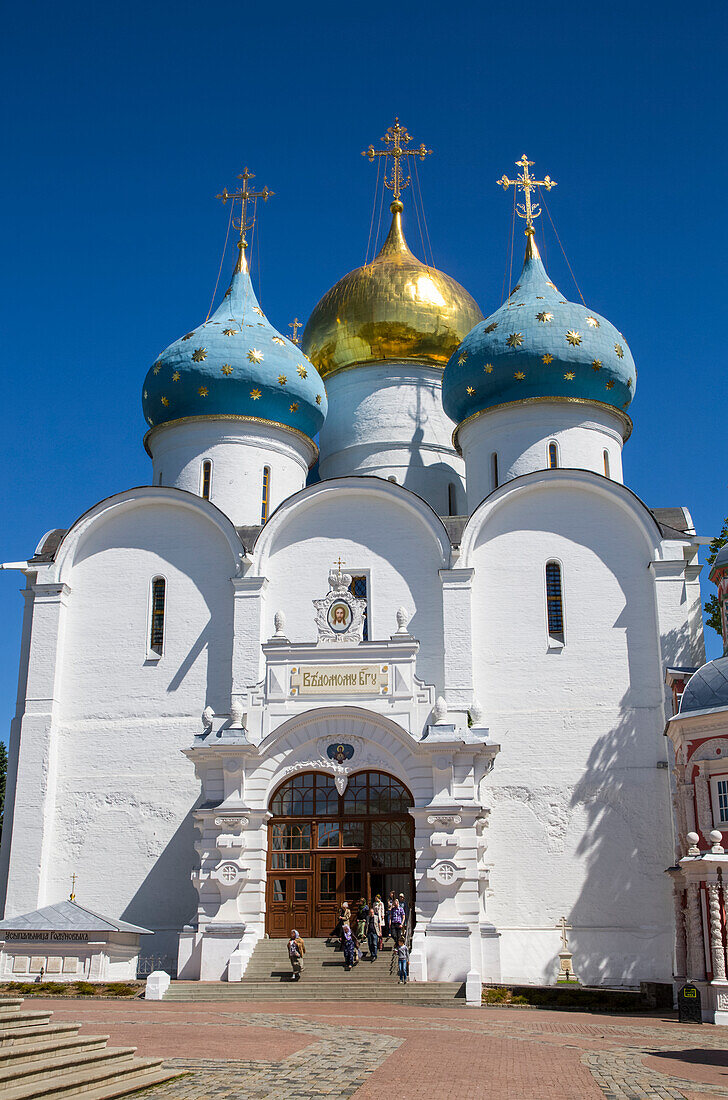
left=142, top=262, right=328, bottom=439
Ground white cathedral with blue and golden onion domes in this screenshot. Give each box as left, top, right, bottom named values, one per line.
left=0, top=141, right=704, bottom=994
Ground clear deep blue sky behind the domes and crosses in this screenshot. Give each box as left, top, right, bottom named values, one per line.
left=0, top=0, right=728, bottom=736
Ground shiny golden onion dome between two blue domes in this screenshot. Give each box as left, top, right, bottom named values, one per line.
left=302, top=201, right=483, bottom=378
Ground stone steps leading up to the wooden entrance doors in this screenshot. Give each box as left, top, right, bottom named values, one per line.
left=165, top=939, right=465, bottom=1008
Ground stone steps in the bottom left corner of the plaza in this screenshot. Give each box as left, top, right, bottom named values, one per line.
left=0, top=998, right=179, bottom=1100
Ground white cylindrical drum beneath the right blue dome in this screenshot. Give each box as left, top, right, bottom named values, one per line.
left=457, top=402, right=625, bottom=513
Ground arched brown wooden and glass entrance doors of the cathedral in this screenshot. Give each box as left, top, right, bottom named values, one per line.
left=265, top=771, right=415, bottom=936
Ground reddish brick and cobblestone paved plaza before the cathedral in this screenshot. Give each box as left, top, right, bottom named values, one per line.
left=33, top=1000, right=728, bottom=1100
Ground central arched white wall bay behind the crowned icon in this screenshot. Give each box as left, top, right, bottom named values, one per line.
left=258, top=482, right=444, bottom=691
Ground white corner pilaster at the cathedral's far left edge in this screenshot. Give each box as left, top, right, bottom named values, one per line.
left=5, top=583, right=70, bottom=916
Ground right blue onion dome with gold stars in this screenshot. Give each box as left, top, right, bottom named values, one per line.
left=442, top=239, right=637, bottom=424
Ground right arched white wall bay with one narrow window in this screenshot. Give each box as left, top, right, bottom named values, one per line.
left=471, top=477, right=672, bottom=985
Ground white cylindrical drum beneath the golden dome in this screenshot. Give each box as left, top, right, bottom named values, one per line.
left=319, top=362, right=465, bottom=516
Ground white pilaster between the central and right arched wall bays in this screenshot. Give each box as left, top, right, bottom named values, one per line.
left=440, top=569, right=475, bottom=724
